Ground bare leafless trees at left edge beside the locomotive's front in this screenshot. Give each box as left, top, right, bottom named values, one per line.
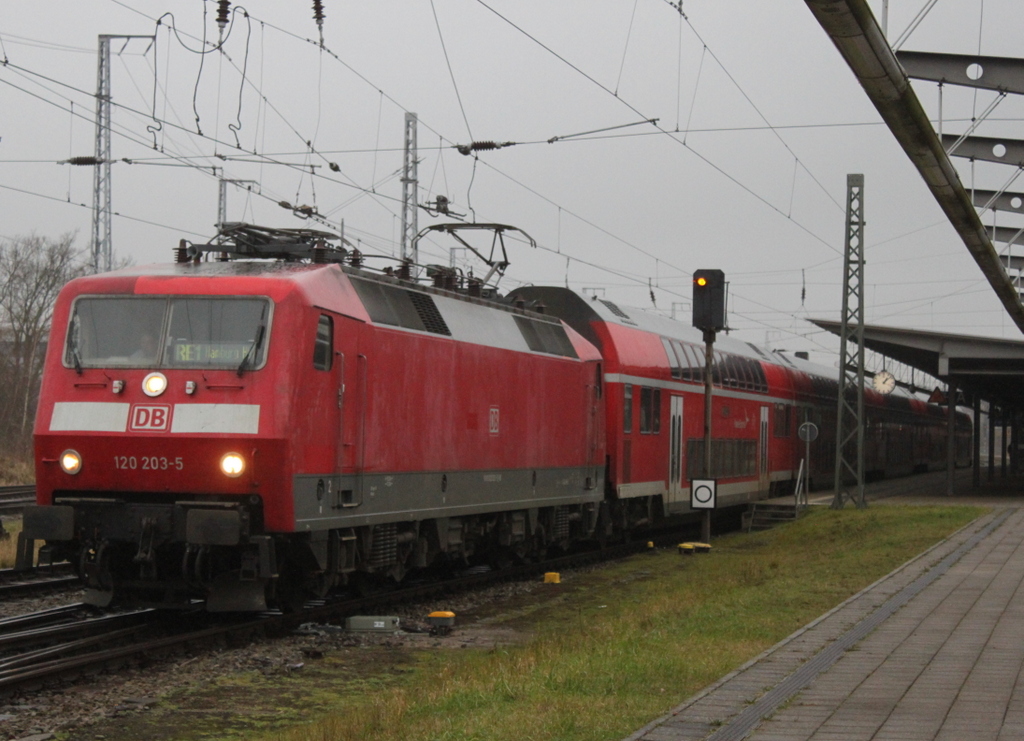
left=0, top=233, right=88, bottom=447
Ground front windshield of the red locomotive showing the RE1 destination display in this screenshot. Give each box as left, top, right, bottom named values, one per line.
left=65, top=296, right=270, bottom=368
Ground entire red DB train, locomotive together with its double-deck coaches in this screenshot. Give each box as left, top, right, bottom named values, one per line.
left=19, top=224, right=970, bottom=611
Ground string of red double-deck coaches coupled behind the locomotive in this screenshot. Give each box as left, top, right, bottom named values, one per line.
left=510, top=287, right=971, bottom=524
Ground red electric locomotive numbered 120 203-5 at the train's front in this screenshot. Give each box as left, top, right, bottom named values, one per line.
left=24, top=227, right=605, bottom=611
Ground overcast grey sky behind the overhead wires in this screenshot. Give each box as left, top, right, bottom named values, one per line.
left=0, top=0, right=1024, bottom=363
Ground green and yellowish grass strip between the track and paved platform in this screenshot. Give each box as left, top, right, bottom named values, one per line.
left=265, top=507, right=983, bottom=741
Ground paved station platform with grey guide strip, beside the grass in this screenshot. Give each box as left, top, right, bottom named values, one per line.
left=626, top=474, right=1024, bottom=741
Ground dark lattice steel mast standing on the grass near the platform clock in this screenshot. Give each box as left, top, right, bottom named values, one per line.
left=831, top=174, right=867, bottom=509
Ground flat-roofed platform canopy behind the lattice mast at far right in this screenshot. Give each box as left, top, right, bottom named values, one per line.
left=811, top=319, right=1024, bottom=407
